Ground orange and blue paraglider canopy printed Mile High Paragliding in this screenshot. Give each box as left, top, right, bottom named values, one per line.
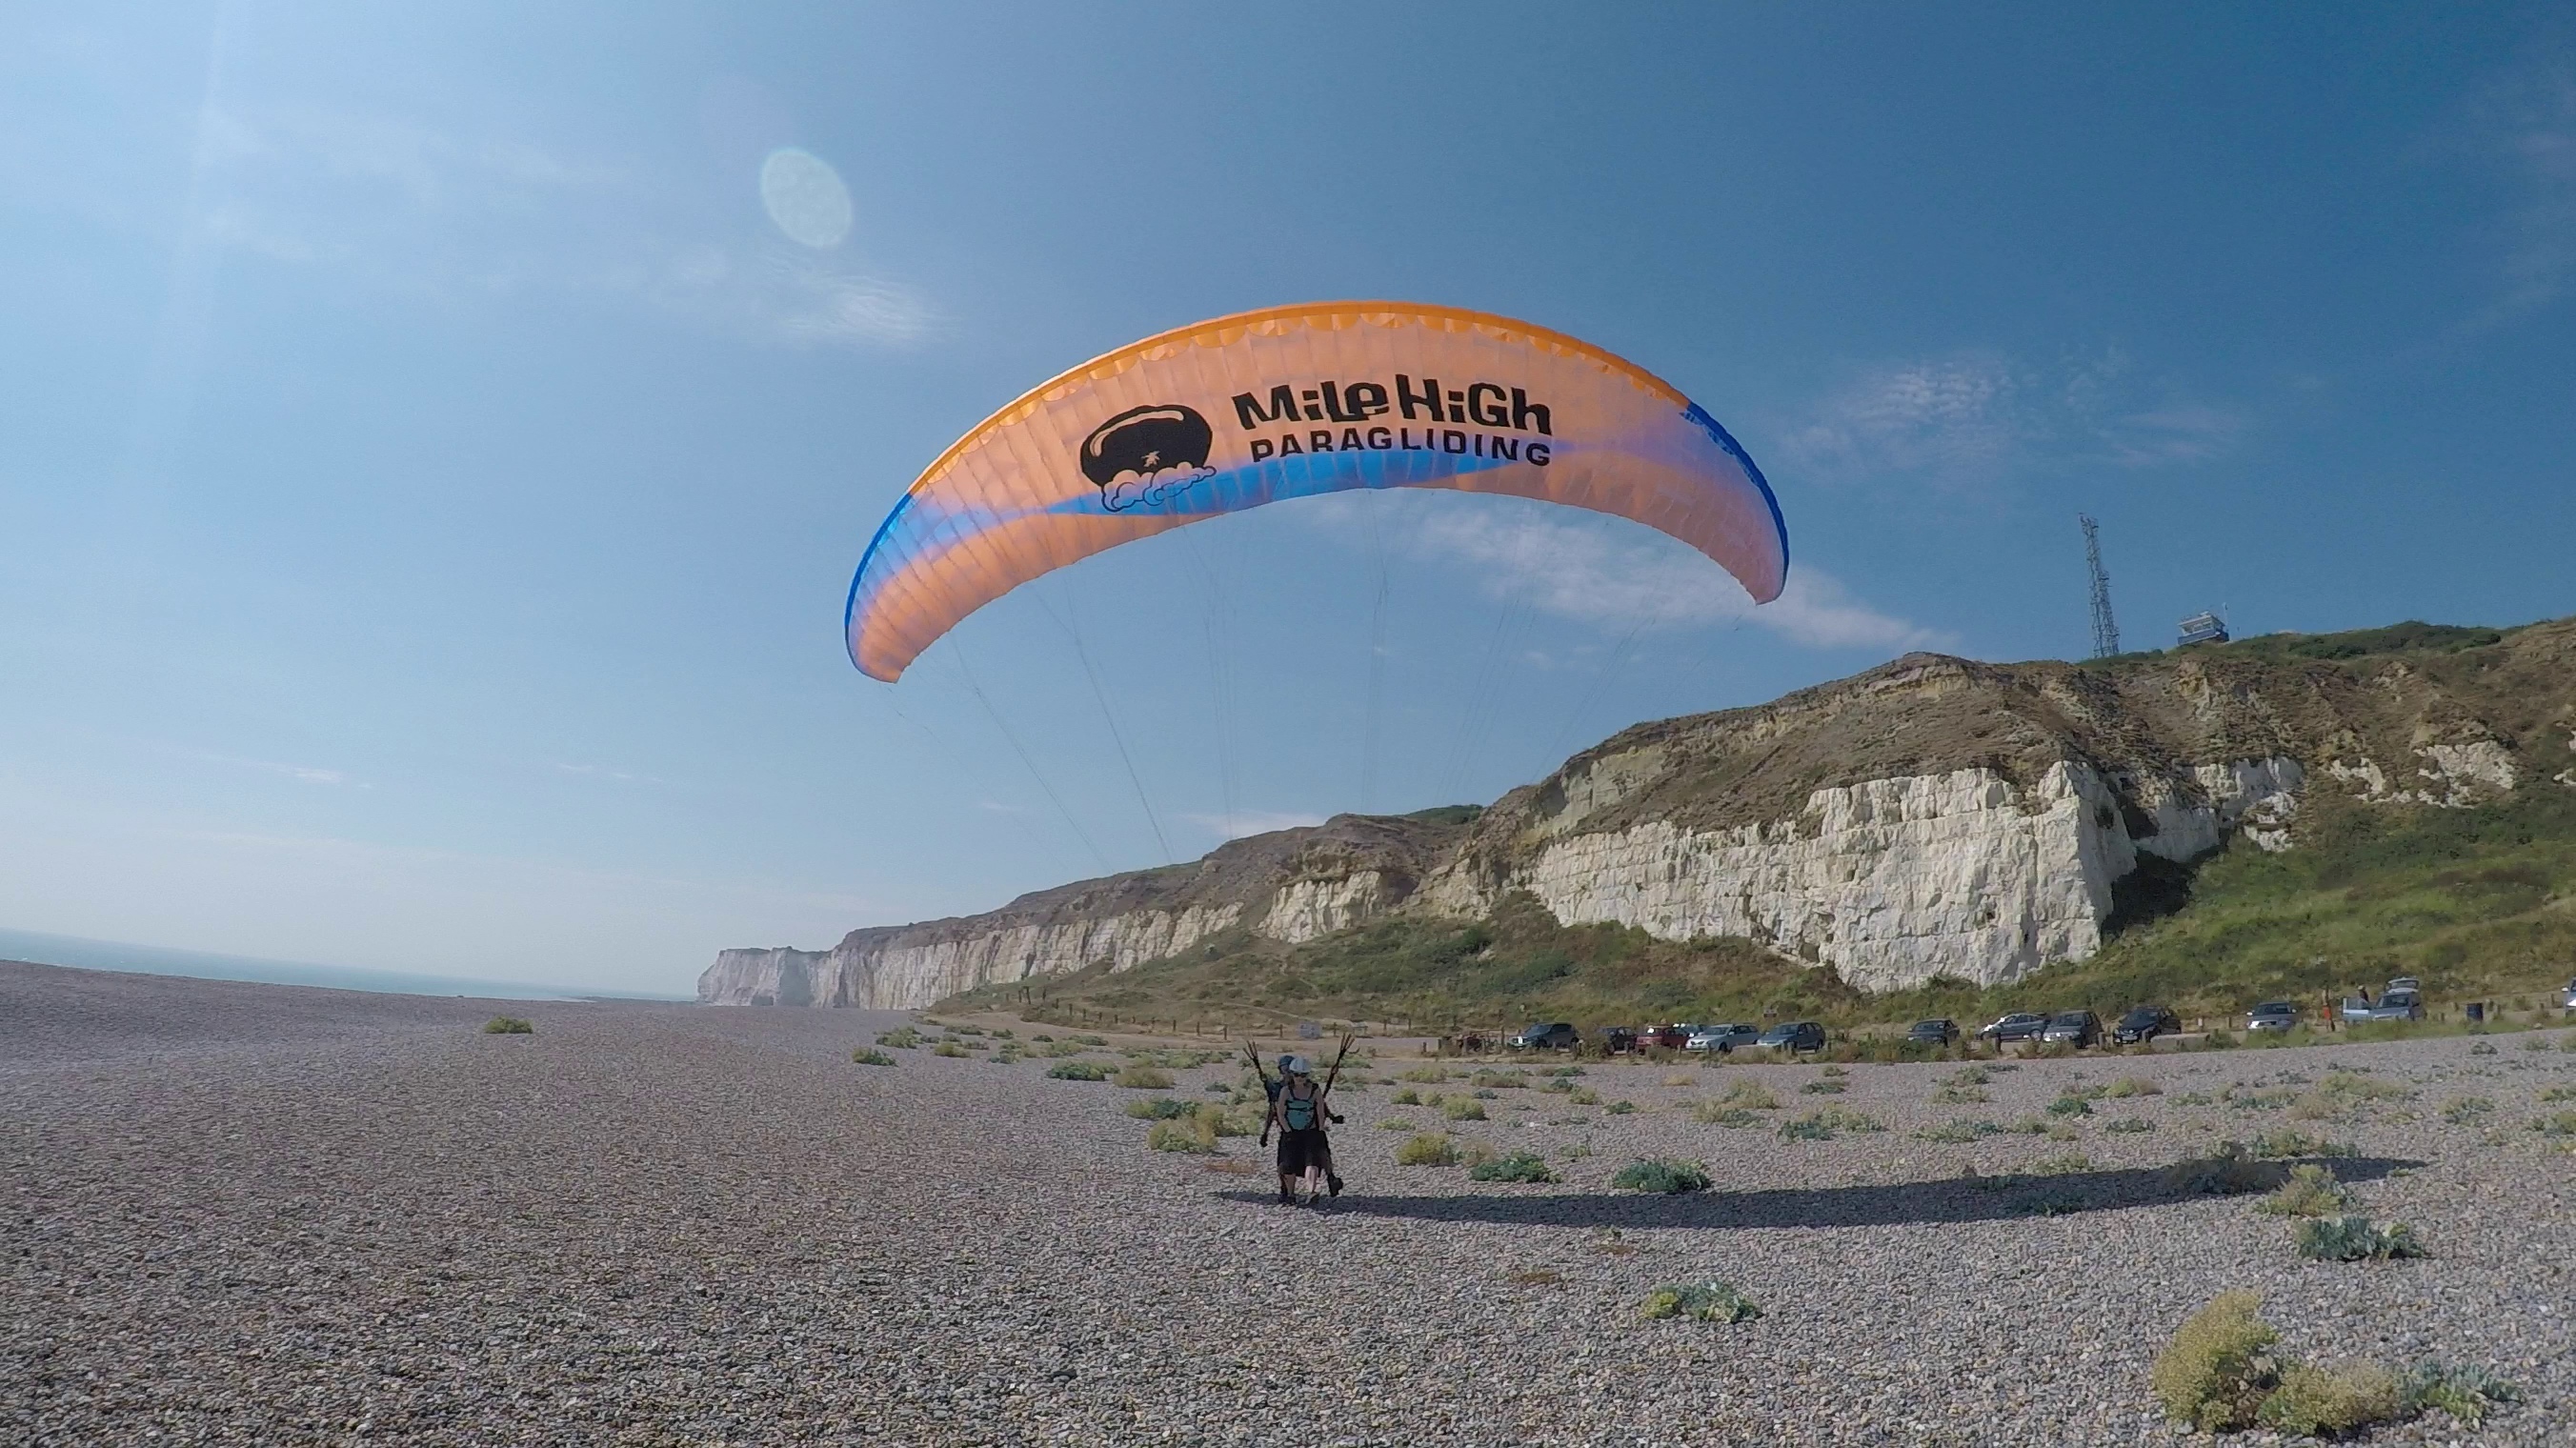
left=842, top=301, right=1788, bottom=683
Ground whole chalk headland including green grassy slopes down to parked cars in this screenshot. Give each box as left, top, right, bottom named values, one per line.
left=698, top=618, right=2576, bottom=1010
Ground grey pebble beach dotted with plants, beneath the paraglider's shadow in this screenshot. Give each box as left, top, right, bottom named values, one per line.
left=0, top=964, right=2576, bottom=1445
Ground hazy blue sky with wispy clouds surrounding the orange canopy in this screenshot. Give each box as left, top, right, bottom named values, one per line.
left=0, top=3, right=2576, bottom=990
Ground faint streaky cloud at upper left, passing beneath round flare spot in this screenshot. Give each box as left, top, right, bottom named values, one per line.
left=196, top=106, right=933, bottom=345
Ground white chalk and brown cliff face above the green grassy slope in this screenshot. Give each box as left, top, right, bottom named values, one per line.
left=698, top=610, right=2576, bottom=1008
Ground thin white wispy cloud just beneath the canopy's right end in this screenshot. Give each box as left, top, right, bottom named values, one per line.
left=1406, top=511, right=1950, bottom=650
